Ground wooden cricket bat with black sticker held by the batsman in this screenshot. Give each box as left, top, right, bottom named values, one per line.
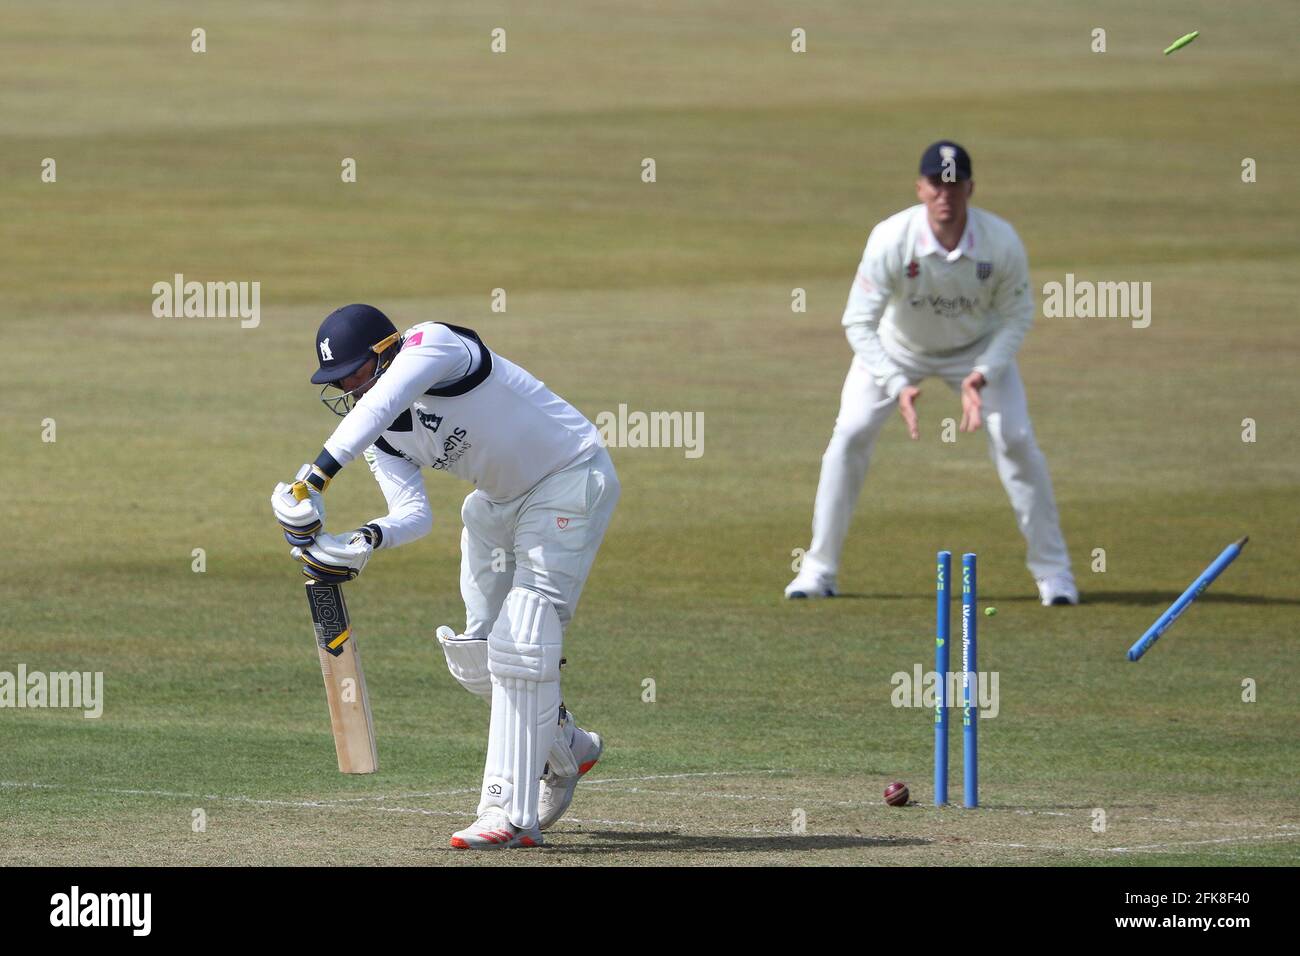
left=307, top=581, right=380, bottom=774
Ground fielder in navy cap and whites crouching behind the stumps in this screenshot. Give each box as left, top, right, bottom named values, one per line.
left=785, top=140, right=1079, bottom=605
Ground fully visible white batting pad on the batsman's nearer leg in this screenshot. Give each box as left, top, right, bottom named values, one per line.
left=478, top=588, right=564, bottom=830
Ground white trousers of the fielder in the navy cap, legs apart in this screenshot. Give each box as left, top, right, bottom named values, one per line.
left=803, top=350, right=1070, bottom=578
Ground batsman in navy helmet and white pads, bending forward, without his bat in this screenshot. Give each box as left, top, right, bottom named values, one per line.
left=272, top=304, right=619, bottom=849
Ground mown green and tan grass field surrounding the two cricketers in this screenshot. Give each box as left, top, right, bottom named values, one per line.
left=0, top=1, right=1300, bottom=865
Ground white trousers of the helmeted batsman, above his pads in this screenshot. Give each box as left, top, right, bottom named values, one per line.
left=460, top=447, right=619, bottom=640
